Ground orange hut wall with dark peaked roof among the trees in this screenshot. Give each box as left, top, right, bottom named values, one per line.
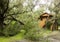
left=39, top=13, right=53, bottom=28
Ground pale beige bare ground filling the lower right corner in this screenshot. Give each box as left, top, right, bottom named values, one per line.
left=48, top=31, right=60, bottom=42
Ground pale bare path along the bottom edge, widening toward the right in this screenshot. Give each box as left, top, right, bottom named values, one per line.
left=17, top=31, right=60, bottom=42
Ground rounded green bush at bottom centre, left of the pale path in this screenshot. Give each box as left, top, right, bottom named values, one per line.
left=25, top=28, right=42, bottom=41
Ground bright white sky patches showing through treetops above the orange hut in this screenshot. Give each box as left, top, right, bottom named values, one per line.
left=35, top=0, right=52, bottom=13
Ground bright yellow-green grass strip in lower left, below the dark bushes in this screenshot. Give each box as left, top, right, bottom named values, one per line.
left=0, top=33, right=24, bottom=42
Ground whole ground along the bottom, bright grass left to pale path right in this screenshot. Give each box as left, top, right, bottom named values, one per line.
left=0, top=31, right=60, bottom=42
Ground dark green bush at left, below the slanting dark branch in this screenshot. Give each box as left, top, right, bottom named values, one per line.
left=3, top=21, right=20, bottom=36
